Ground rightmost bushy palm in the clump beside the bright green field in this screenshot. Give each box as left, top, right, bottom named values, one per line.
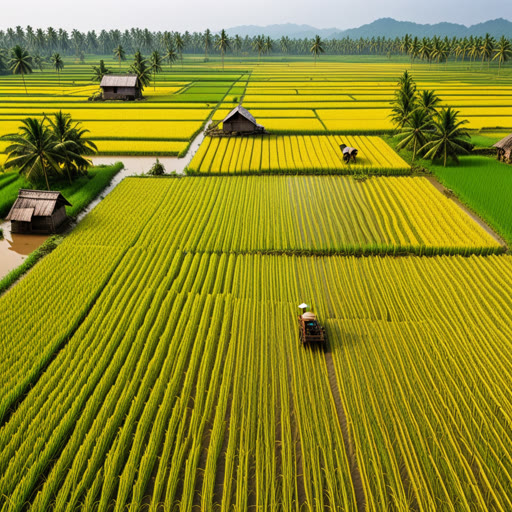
left=422, top=107, right=473, bottom=167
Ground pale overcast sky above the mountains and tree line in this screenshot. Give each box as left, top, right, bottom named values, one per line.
left=0, top=0, right=512, bottom=31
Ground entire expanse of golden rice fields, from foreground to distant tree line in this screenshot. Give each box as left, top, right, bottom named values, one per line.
left=0, top=55, right=512, bottom=512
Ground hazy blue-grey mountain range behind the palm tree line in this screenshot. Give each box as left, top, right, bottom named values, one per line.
left=226, top=18, right=512, bottom=39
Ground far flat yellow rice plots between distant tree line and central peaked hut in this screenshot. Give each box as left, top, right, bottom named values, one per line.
left=0, top=58, right=512, bottom=158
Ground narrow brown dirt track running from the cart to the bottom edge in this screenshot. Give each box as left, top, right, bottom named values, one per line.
left=325, top=351, right=366, bottom=512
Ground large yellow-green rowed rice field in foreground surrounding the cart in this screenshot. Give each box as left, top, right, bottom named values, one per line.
left=0, top=176, right=512, bottom=512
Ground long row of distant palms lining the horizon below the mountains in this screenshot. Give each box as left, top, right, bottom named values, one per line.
left=0, top=26, right=512, bottom=67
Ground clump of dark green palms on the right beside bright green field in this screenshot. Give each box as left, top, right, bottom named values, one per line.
left=391, top=71, right=473, bottom=167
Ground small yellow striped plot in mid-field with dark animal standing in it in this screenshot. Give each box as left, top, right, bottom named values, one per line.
left=188, top=135, right=410, bottom=175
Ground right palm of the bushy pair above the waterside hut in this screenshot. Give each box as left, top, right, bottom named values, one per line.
left=47, top=111, right=98, bottom=183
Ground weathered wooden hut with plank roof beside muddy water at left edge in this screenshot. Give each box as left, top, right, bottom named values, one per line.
left=6, top=188, right=71, bottom=234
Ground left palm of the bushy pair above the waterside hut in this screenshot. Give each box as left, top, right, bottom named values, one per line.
left=1, top=117, right=62, bottom=190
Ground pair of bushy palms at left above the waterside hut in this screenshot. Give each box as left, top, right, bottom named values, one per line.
left=0, top=111, right=97, bottom=190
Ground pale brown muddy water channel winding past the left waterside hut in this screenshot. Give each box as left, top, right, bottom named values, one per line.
left=0, top=129, right=208, bottom=279
